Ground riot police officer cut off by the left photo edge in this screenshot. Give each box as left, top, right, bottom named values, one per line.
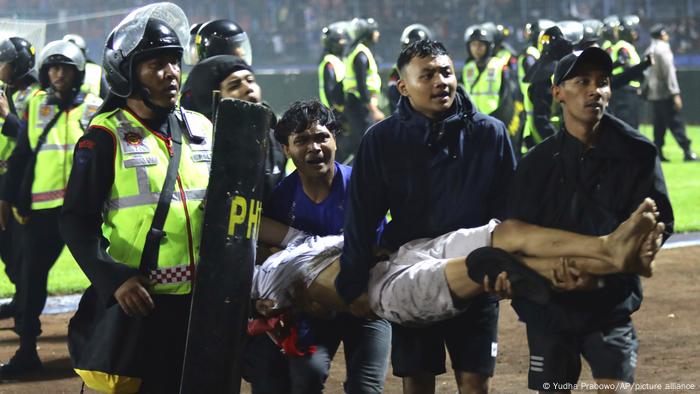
left=0, top=37, right=40, bottom=319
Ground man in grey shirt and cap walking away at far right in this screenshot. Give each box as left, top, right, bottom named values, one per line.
left=645, top=24, right=698, bottom=161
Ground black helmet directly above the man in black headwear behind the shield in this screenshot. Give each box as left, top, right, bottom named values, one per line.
left=195, top=19, right=253, bottom=65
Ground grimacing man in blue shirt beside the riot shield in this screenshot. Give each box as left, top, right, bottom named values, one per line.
left=246, top=101, right=391, bottom=394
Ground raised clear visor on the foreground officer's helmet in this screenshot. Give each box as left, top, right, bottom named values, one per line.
left=112, top=3, right=190, bottom=57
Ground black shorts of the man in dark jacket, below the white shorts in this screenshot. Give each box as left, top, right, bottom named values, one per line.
left=391, top=296, right=498, bottom=377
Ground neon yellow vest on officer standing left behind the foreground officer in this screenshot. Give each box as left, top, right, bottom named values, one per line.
left=27, top=92, right=102, bottom=210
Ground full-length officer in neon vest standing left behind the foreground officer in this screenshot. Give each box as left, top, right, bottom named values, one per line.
left=0, top=41, right=102, bottom=378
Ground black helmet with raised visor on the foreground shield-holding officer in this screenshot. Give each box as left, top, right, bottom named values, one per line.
left=102, top=3, right=189, bottom=97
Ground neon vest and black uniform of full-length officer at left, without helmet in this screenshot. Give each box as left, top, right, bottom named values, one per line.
left=2, top=87, right=102, bottom=370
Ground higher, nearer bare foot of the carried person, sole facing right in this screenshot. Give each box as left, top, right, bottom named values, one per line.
left=604, top=198, right=657, bottom=273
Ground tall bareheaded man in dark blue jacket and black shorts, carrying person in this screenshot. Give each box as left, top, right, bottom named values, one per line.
left=336, top=40, right=515, bottom=393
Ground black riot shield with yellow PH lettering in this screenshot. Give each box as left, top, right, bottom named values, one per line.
left=180, top=99, right=274, bottom=393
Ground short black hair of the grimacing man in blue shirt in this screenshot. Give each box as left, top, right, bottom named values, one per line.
left=275, top=100, right=340, bottom=145
